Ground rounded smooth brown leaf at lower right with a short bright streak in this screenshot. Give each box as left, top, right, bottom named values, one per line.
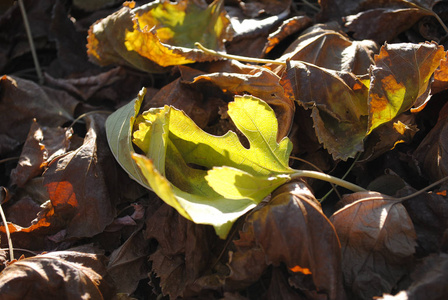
left=330, top=192, right=417, bottom=299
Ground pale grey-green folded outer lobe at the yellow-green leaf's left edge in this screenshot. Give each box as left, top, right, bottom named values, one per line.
left=106, top=88, right=147, bottom=186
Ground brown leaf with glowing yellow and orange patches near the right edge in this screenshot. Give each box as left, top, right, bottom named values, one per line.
left=368, top=42, right=445, bottom=133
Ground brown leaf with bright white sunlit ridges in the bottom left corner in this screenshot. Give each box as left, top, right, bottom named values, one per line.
left=0, top=251, right=114, bottom=300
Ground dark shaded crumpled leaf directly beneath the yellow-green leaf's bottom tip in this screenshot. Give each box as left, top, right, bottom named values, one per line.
left=145, top=203, right=217, bottom=299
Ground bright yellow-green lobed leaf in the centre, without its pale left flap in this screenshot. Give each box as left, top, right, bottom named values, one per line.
left=132, top=96, right=294, bottom=238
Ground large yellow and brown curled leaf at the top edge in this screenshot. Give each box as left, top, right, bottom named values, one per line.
left=88, top=0, right=232, bottom=72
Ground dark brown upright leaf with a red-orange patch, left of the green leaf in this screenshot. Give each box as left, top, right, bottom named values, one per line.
left=43, top=115, right=118, bottom=237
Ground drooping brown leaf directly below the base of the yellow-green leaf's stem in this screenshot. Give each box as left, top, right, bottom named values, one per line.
left=246, top=182, right=345, bottom=299
